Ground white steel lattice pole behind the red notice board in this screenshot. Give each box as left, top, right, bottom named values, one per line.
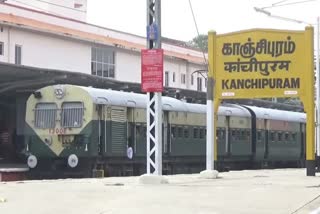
left=147, top=0, right=163, bottom=175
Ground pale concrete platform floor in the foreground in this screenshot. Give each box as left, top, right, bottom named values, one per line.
left=0, top=169, right=320, bottom=214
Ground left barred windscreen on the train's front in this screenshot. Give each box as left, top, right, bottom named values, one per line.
left=34, top=103, right=58, bottom=129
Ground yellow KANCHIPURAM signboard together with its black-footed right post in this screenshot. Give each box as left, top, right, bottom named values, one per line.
left=208, top=27, right=315, bottom=176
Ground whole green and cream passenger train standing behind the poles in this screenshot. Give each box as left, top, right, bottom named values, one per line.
left=25, top=85, right=305, bottom=177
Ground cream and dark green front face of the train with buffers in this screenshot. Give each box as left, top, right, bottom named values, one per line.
left=25, top=85, right=93, bottom=169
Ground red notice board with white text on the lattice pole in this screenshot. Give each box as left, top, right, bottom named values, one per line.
left=141, top=49, right=163, bottom=92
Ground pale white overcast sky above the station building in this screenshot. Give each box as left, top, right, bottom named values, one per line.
left=87, top=0, right=320, bottom=41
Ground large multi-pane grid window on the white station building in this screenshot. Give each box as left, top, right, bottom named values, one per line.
left=91, top=47, right=115, bottom=78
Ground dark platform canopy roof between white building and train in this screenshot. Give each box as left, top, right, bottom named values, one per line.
left=0, top=63, right=206, bottom=103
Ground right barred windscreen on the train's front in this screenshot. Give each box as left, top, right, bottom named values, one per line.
left=61, top=102, right=84, bottom=128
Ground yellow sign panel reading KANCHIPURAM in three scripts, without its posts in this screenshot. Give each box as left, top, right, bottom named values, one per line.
left=209, top=29, right=312, bottom=99
